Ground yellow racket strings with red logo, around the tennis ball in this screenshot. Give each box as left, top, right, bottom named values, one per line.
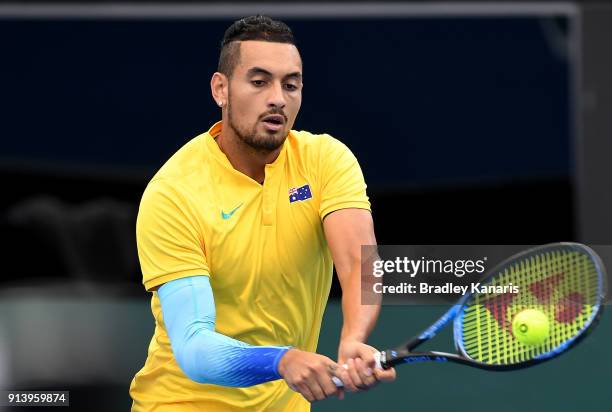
left=456, top=249, right=601, bottom=365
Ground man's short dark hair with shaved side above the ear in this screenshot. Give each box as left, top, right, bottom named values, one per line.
left=217, top=14, right=295, bottom=77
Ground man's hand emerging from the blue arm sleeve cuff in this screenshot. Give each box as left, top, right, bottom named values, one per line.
left=278, top=349, right=344, bottom=402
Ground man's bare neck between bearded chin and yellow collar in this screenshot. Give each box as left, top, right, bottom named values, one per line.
left=216, top=127, right=282, bottom=183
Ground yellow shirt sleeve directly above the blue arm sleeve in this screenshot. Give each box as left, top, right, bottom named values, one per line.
left=136, top=180, right=209, bottom=290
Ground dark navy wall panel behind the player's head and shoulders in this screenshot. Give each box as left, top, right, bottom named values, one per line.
left=0, top=17, right=574, bottom=189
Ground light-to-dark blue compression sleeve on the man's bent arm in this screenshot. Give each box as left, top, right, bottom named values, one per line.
left=157, top=276, right=290, bottom=387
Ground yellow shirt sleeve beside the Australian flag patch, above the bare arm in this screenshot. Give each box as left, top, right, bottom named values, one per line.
left=319, top=136, right=370, bottom=220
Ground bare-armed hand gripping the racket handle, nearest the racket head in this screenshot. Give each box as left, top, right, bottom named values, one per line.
left=336, top=340, right=395, bottom=392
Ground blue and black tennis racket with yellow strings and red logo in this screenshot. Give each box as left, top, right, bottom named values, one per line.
left=333, top=243, right=606, bottom=386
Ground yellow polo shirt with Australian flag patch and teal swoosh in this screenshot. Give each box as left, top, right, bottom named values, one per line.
left=130, top=122, right=370, bottom=412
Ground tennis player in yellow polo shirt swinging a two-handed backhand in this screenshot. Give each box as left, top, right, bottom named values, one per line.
left=130, top=16, right=395, bottom=412
